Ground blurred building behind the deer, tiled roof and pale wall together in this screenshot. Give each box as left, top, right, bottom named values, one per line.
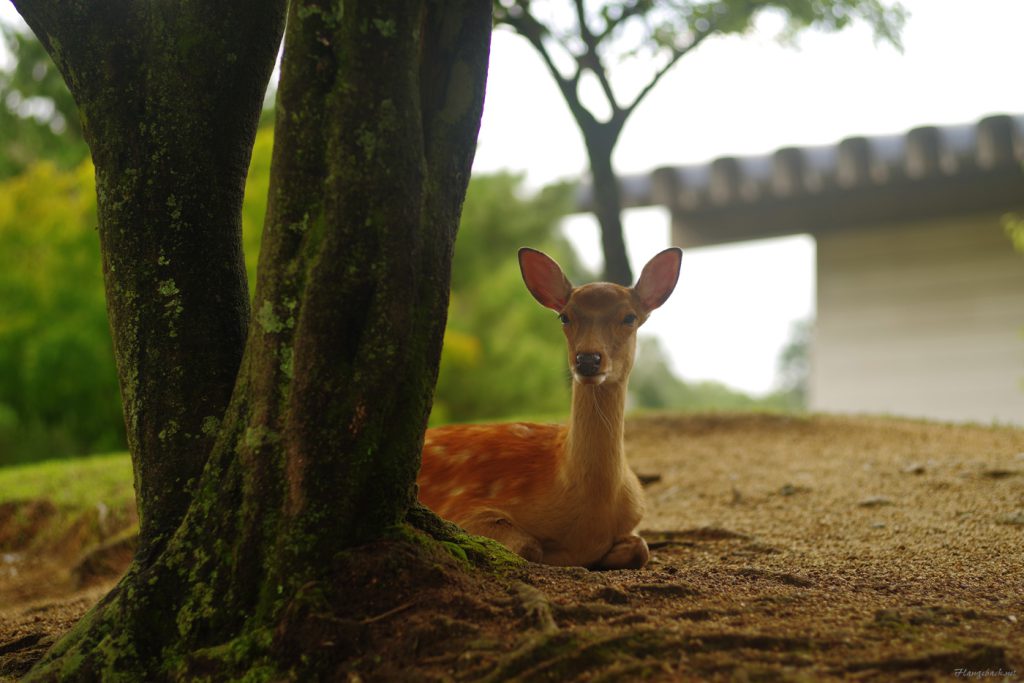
left=581, top=116, right=1024, bottom=423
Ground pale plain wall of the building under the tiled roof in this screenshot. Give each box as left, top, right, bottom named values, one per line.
left=811, top=214, right=1024, bottom=423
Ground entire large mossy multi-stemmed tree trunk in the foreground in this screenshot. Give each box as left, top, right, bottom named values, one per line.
left=17, top=0, right=490, bottom=679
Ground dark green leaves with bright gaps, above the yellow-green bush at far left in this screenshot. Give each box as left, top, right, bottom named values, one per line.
left=0, top=25, right=89, bottom=178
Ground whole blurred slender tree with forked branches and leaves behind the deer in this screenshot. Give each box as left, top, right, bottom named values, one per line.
left=495, top=0, right=905, bottom=285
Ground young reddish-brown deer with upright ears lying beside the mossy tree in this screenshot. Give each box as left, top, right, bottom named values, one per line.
left=418, top=248, right=682, bottom=569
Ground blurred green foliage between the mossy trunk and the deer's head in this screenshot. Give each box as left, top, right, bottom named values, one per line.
left=431, top=174, right=590, bottom=424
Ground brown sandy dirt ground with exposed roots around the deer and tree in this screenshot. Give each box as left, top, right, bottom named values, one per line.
left=0, top=415, right=1024, bottom=681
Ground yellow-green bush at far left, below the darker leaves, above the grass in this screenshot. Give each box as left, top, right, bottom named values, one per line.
left=0, top=163, right=124, bottom=464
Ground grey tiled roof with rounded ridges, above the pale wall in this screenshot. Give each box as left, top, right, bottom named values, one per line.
left=579, top=115, right=1024, bottom=247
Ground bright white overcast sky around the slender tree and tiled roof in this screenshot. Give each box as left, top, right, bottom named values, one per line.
left=474, top=0, right=1024, bottom=393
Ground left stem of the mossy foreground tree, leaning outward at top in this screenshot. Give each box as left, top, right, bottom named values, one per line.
left=14, top=0, right=284, bottom=558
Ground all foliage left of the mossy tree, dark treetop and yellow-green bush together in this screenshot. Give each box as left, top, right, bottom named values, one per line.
left=0, top=34, right=124, bottom=465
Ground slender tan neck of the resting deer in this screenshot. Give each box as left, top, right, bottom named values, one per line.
left=562, top=382, right=628, bottom=489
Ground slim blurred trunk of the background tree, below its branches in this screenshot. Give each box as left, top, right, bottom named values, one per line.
left=581, top=126, right=633, bottom=287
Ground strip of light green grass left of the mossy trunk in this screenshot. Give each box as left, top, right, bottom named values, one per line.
left=0, top=453, right=135, bottom=509
